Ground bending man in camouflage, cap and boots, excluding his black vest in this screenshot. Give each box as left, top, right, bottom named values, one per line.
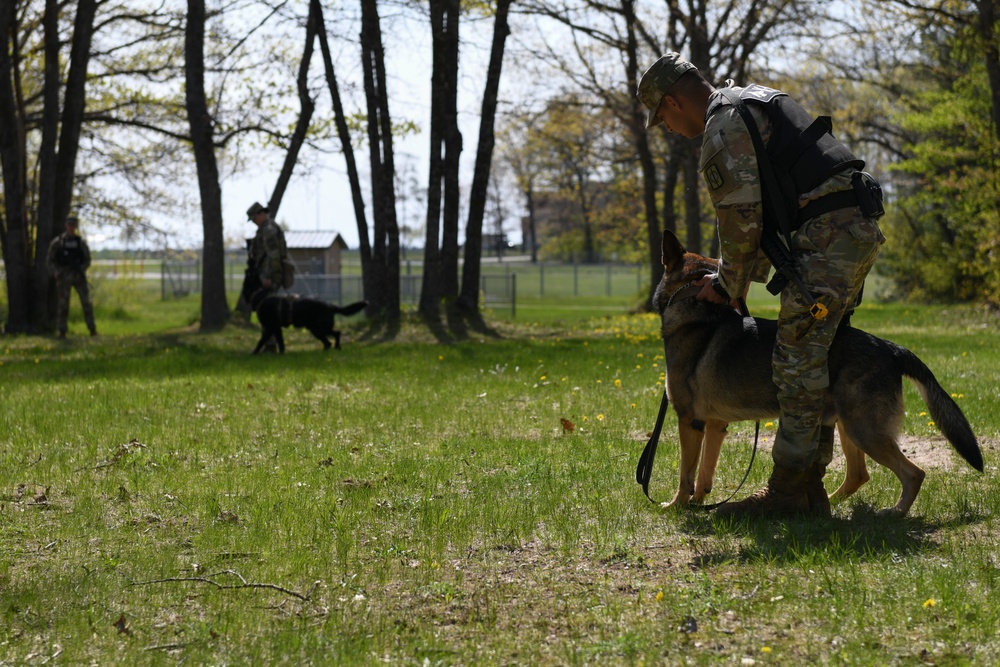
left=638, top=53, right=885, bottom=516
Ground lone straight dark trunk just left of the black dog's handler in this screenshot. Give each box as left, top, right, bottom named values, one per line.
left=184, top=0, right=229, bottom=331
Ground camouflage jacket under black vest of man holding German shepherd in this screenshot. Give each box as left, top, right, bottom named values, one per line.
left=699, top=87, right=854, bottom=297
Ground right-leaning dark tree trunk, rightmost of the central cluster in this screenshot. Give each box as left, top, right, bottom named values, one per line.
left=458, top=0, right=511, bottom=313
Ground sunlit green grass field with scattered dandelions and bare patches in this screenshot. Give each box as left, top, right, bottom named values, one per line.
left=0, top=286, right=1000, bottom=665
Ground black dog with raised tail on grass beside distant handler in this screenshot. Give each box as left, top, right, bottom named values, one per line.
left=251, top=292, right=368, bottom=354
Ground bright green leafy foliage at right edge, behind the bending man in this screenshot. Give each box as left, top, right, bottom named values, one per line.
left=883, top=41, right=1000, bottom=304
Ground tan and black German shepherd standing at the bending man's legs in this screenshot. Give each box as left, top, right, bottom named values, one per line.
left=653, top=231, right=983, bottom=516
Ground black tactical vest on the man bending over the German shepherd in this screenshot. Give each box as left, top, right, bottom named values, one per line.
left=709, top=83, right=865, bottom=220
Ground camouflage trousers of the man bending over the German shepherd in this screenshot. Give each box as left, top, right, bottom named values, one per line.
left=772, top=208, right=885, bottom=470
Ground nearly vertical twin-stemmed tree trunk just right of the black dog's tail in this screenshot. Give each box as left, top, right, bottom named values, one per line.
left=361, top=0, right=400, bottom=325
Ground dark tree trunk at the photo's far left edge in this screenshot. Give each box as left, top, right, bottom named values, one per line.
left=0, top=2, right=29, bottom=333
